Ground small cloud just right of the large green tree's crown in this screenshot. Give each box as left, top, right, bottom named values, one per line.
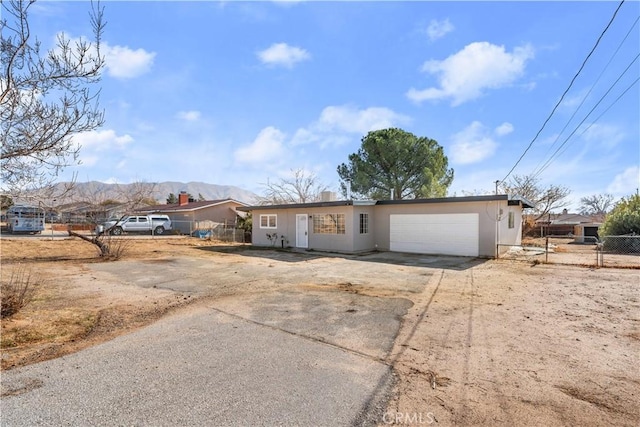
left=451, top=121, right=498, bottom=165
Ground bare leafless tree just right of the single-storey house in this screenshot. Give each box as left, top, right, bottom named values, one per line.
left=502, top=175, right=571, bottom=220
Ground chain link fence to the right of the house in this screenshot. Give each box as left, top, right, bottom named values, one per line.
left=498, top=236, right=640, bottom=268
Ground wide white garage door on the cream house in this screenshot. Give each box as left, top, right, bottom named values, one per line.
left=390, top=213, right=480, bottom=256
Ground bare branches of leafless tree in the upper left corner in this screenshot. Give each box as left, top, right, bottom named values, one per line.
left=0, top=0, right=105, bottom=195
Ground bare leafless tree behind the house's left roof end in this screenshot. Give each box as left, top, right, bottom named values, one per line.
left=259, top=169, right=328, bottom=205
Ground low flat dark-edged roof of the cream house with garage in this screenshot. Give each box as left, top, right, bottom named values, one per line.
left=238, top=194, right=534, bottom=212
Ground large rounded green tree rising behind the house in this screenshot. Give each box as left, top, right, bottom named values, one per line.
left=338, top=128, right=453, bottom=199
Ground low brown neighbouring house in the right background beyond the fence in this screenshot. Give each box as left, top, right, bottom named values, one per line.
left=536, top=209, right=604, bottom=243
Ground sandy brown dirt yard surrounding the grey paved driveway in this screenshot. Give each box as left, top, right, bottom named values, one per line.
left=0, top=237, right=640, bottom=426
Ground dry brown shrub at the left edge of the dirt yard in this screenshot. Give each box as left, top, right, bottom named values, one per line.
left=0, top=264, right=41, bottom=319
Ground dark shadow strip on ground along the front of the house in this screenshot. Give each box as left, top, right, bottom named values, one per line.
left=197, top=246, right=487, bottom=270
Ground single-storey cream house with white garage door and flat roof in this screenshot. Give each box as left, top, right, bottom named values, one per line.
left=238, top=195, right=533, bottom=257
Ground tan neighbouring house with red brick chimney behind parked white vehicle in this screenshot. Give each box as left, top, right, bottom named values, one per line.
left=137, top=192, right=248, bottom=234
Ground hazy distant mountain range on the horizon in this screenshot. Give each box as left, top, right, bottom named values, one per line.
left=46, top=181, right=258, bottom=204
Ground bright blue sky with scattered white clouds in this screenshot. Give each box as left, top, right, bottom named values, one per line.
left=31, top=1, right=640, bottom=206
